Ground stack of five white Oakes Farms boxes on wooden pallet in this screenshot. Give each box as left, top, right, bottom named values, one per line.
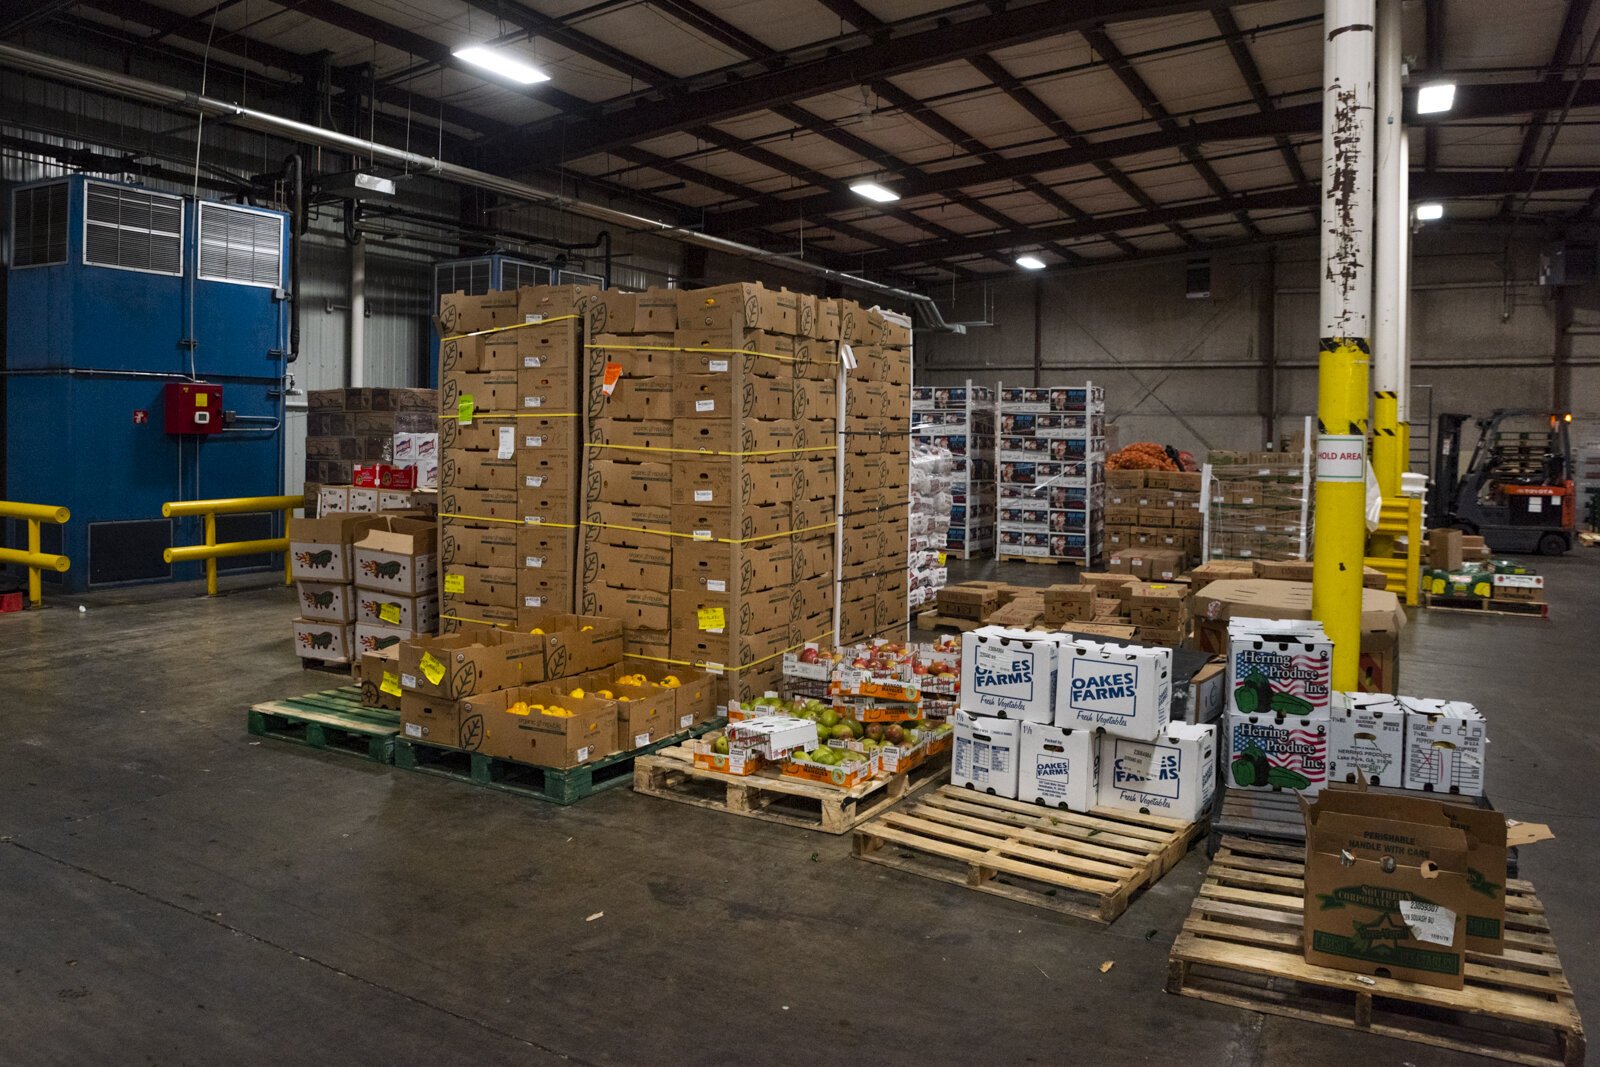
left=950, top=627, right=1216, bottom=821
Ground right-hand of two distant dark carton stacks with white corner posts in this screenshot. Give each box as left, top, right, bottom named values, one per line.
left=995, top=384, right=1106, bottom=566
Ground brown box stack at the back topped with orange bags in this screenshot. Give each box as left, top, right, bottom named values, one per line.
left=1106, top=470, right=1205, bottom=566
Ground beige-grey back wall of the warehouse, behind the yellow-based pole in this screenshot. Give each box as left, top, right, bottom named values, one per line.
left=917, top=226, right=1600, bottom=467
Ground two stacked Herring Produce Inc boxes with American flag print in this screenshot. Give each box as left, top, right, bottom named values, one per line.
left=1226, top=617, right=1333, bottom=797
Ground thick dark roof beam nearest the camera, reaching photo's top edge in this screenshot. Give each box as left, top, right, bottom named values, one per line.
left=486, top=0, right=1235, bottom=166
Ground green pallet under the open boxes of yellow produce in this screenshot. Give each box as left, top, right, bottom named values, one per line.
left=395, top=718, right=723, bottom=805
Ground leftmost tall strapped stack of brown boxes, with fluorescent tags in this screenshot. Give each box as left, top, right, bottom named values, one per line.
left=438, top=286, right=592, bottom=632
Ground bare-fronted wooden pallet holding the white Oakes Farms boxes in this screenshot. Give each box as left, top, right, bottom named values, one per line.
left=854, top=785, right=1202, bottom=923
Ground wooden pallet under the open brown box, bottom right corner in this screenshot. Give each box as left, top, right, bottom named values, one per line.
left=1166, top=837, right=1584, bottom=1067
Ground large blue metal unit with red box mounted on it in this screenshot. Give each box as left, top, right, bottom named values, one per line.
left=5, top=174, right=288, bottom=590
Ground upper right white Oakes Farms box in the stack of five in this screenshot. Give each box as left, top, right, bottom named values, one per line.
left=1054, top=638, right=1173, bottom=741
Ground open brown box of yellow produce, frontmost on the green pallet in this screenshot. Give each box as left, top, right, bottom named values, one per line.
left=478, top=685, right=618, bottom=768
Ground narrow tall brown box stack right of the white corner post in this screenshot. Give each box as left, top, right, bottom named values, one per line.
left=838, top=301, right=910, bottom=645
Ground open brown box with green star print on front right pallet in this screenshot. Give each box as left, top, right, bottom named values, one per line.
left=1304, top=789, right=1475, bottom=989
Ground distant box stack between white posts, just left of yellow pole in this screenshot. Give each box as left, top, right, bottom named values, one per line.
left=1205, top=448, right=1312, bottom=560
